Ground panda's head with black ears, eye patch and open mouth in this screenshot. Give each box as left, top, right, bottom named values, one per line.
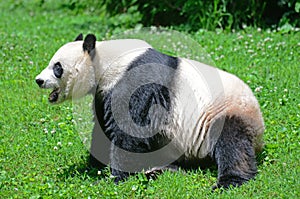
left=35, top=34, right=96, bottom=103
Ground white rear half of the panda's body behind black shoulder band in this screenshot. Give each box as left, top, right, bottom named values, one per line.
left=169, top=59, right=264, bottom=159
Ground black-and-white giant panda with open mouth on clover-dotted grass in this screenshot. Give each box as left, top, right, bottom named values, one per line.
left=35, top=34, right=264, bottom=188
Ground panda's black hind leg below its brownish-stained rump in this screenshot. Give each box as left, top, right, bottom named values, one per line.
left=213, top=117, right=257, bottom=189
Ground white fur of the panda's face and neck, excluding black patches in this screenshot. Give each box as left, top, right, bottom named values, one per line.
left=36, top=39, right=150, bottom=103
